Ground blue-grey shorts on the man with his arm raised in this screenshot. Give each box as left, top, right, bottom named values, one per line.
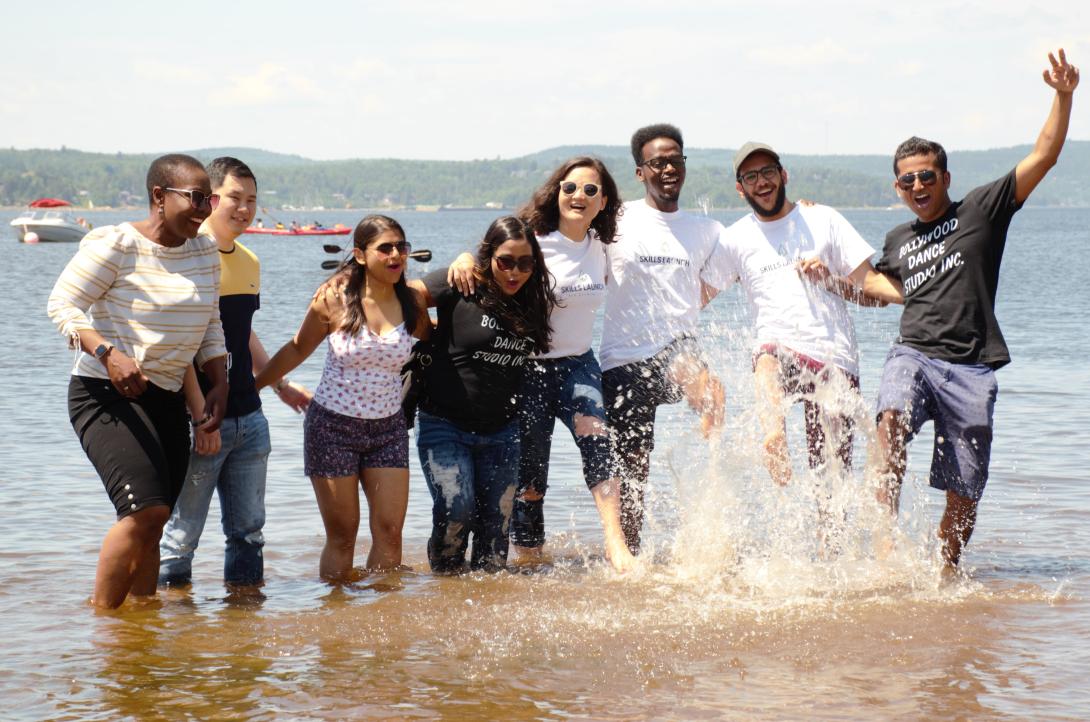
left=877, top=345, right=1000, bottom=502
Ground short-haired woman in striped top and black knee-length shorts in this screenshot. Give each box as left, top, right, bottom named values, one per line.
left=49, top=154, right=228, bottom=609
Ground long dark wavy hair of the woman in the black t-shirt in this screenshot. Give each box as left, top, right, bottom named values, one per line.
left=474, top=216, right=556, bottom=353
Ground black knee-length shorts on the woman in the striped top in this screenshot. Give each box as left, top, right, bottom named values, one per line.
left=69, top=376, right=190, bottom=519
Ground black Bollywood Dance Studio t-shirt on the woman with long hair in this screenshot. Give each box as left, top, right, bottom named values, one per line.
left=420, top=268, right=533, bottom=433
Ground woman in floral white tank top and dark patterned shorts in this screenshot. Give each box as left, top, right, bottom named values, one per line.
left=256, top=215, right=431, bottom=581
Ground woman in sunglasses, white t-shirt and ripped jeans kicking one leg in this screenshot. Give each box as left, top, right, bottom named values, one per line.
left=451, top=156, right=634, bottom=571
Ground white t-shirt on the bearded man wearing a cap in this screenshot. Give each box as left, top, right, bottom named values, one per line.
left=715, top=205, right=874, bottom=375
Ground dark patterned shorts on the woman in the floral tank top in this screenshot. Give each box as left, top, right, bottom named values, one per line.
left=303, top=401, right=409, bottom=478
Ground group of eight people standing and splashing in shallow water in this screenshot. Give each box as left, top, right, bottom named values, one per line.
left=49, top=50, right=1078, bottom=607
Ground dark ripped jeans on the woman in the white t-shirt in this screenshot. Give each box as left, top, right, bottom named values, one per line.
left=511, top=351, right=613, bottom=546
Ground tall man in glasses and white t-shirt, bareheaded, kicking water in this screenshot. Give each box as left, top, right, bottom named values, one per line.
left=600, top=123, right=724, bottom=553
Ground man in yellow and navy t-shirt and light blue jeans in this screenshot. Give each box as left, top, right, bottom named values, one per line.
left=159, top=157, right=310, bottom=586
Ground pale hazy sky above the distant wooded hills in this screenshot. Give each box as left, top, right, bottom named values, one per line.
left=0, top=0, right=1090, bottom=159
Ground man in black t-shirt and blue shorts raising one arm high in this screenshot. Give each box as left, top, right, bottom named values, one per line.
left=876, top=49, right=1079, bottom=567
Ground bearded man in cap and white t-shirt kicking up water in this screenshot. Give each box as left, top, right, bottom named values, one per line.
left=714, top=142, right=901, bottom=485
